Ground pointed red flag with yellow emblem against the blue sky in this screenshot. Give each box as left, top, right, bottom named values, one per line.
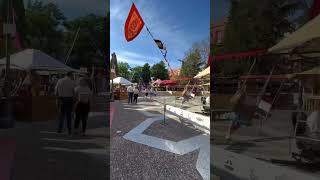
left=124, top=4, right=144, bottom=42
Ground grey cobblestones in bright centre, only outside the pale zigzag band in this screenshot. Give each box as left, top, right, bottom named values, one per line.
left=110, top=102, right=202, bottom=179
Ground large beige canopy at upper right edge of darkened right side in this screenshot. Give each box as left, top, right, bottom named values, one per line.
left=268, top=15, right=320, bottom=56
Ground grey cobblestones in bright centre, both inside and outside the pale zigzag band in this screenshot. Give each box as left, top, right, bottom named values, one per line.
left=110, top=98, right=209, bottom=180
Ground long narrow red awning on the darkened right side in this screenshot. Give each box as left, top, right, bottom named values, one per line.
left=213, top=49, right=267, bottom=61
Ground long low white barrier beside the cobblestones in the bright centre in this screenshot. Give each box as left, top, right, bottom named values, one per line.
left=166, top=105, right=210, bottom=134
